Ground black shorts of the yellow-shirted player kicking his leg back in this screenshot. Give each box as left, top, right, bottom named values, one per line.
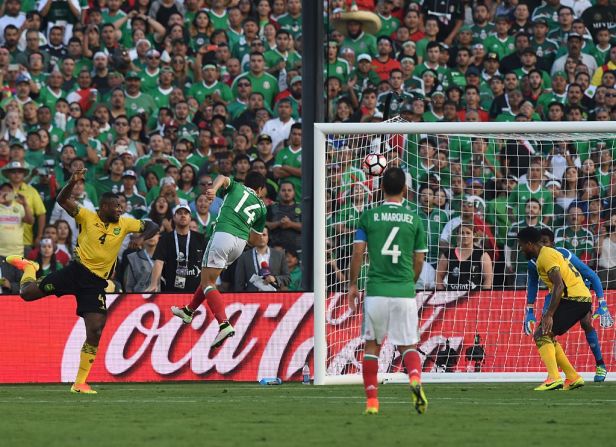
left=39, top=261, right=107, bottom=317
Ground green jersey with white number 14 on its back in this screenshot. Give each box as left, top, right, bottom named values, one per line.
left=214, top=179, right=267, bottom=240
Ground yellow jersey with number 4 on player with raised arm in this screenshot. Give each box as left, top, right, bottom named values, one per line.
left=75, top=207, right=144, bottom=279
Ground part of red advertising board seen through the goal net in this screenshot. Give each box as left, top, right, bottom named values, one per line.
left=326, top=291, right=613, bottom=375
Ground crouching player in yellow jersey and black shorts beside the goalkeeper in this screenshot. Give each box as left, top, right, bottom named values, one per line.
left=518, top=227, right=592, bottom=391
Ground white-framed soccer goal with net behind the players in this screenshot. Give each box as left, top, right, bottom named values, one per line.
left=314, top=118, right=616, bottom=385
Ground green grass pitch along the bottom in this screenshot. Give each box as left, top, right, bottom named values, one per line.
left=0, top=382, right=616, bottom=447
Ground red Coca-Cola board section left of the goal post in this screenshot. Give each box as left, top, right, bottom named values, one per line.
left=0, top=293, right=314, bottom=383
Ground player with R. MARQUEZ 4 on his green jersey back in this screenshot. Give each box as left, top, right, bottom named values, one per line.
left=347, top=168, right=428, bottom=414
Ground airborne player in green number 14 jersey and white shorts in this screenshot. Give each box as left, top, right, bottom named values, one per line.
left=171, top=172, right=267, bottom=348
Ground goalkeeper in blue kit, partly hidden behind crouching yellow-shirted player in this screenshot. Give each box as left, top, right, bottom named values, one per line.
left=524, top=228, right=614, bottom=382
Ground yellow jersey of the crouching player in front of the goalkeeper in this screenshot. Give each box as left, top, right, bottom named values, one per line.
left=537, top=247, right=591, bottom=301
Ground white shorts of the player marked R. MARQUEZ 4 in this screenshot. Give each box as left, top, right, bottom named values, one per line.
left=363, top=296, right=419, bottom=346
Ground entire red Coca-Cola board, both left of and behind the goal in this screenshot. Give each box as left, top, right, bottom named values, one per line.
left=0, top=291, right=616, bottom=383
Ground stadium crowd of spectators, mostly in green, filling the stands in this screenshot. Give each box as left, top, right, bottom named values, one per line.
left=0, top=0, right=616, bottom=292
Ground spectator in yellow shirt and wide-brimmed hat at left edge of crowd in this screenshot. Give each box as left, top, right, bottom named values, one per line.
left=2, top=161, right=47, bottom=249
